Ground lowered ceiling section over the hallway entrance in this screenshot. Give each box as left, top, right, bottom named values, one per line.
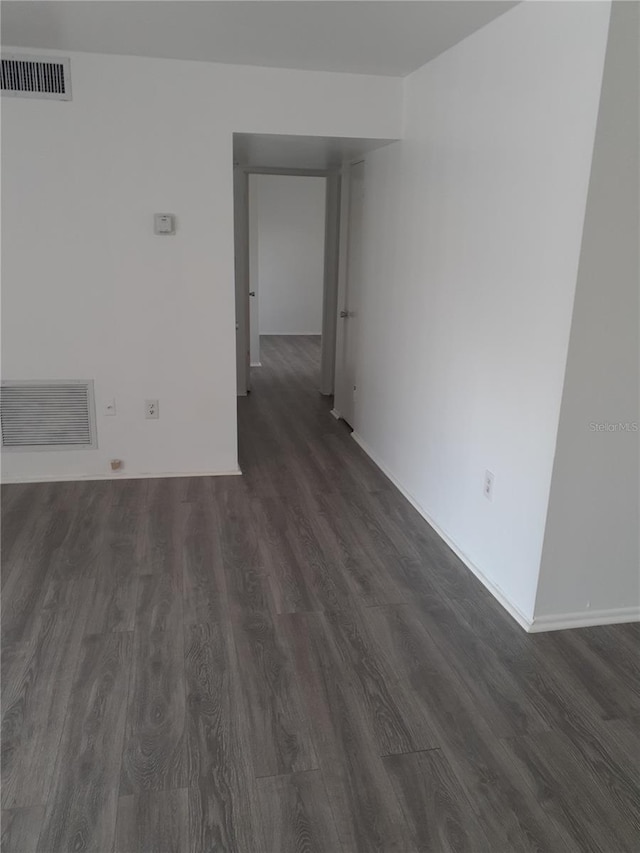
left=233, top=133, right=394, bottom=169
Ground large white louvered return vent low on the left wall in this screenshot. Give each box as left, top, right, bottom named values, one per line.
left=0, top=379, right=98, bottom=451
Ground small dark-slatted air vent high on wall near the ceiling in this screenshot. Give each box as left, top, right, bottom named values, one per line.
left=0, top=54, right=71, bottom=101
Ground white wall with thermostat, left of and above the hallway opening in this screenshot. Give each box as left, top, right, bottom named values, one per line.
left=2, top=51, right=402, bottom=479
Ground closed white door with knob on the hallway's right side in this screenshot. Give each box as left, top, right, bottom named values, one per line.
left=336, top=161, right=364, bottom=426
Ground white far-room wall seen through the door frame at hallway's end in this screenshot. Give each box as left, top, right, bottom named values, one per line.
left=249, top=175, right=326, bottom=340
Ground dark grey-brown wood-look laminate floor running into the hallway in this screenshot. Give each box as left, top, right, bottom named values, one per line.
left=2, top=337, right=640, bottom=853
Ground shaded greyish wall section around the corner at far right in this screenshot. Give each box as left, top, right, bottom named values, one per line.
left=535, top=3, right=640, bottom=626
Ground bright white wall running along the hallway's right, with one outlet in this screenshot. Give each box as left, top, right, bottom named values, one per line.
left=336, top=3, right=609, bottom=624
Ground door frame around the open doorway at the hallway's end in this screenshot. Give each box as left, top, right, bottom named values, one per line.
left=233, top=163, right=343, bottom=397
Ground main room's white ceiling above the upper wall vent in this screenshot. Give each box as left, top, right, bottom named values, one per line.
left=1, top=0, right=516, bottom=77
